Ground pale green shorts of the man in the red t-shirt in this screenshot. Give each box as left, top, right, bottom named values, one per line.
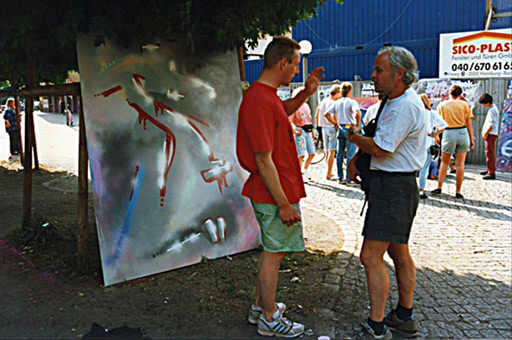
left=251, top=201, right=306, bottom=253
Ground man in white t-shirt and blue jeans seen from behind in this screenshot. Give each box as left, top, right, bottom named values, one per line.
left=327, top=82, right=361, bottom=186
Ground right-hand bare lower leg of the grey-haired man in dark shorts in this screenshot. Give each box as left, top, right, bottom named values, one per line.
left=388, top=243, right=416, bottom=308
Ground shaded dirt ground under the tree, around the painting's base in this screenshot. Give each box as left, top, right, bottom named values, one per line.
left=0, top=162, right=343, bottom=339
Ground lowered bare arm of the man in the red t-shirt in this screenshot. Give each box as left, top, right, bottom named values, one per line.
left=256, top=151, right=300, bottom=226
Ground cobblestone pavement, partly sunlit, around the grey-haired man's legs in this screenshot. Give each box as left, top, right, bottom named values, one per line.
left=301, top=162, right=512, bottom=339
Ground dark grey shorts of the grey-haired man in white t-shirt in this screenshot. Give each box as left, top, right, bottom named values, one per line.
left=363, top=171, right=420, bottom=244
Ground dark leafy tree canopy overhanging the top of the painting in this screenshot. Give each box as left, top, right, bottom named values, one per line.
left=0, top=0, right=343, bottom=83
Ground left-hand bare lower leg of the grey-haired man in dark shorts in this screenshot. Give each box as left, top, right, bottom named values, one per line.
left=361, top=237, right=390, bottom=322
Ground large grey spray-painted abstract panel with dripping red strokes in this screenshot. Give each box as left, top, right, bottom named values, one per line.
left=77, top=36, right=260, bottom=285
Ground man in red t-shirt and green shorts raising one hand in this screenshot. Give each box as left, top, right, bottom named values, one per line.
left=237, top=37, right=323, bottom=337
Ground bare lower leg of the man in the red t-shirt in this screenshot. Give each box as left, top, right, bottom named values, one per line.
left=254, top=251, right=285, bottom=322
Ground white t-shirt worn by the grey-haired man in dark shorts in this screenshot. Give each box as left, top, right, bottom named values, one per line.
left=370, top=88, right=427, bottom=172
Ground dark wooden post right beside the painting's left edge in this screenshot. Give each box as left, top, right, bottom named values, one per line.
left=77, top=100, right=89, bottom=272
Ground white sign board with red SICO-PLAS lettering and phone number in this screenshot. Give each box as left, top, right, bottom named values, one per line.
left=439, top=28, right=512, bottom=79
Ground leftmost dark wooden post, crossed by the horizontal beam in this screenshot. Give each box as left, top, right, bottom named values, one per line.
left=21, top=57, right=36, bottom=229
